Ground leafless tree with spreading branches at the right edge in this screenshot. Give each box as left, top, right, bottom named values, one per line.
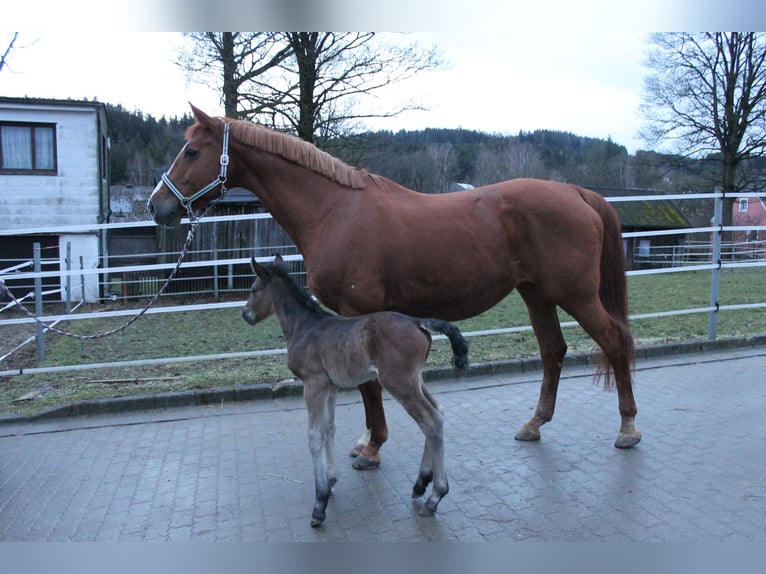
left=641, top=32, right=766, bottom=230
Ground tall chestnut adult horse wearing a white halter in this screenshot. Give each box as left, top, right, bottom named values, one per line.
left=148, top=106, right=641, bottom=468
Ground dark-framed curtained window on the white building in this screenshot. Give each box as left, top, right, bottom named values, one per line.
left=0, top=123, right=56, bottom=174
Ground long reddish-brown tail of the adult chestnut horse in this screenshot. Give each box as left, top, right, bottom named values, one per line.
left=583, top=192, right=636, bottom=388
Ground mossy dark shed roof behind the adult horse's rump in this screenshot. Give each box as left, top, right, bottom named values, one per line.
left=589, top=187, right=693, bottom=230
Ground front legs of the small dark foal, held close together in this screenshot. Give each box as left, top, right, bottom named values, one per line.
left=303, top=379, right=336, bottom=527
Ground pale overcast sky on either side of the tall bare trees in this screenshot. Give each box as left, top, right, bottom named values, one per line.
left=0, top=30, right=656, bottom=152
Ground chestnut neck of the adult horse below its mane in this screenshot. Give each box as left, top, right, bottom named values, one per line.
left=232, top=148, right=358, bottom=251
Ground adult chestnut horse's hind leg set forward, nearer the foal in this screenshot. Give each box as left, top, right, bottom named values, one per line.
left=514, top=283, right=567, bottom=441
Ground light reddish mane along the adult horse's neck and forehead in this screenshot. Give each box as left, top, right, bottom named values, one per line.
left=202, top=119, right=370, bottom=189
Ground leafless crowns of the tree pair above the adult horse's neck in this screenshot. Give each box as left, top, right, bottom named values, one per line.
left=179, top=32, right=441, bottom=143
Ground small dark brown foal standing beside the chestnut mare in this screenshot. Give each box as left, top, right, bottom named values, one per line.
left=242, top=255, right=468, bottom=526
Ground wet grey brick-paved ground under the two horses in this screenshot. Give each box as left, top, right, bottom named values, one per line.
left=0, top=347, right=766, bottom=542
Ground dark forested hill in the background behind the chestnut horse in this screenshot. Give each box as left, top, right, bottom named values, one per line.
left=106, top=104, right=766, bottom=201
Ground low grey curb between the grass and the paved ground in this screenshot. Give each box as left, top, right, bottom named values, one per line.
left=0, top=333, right=766, bottom=424
